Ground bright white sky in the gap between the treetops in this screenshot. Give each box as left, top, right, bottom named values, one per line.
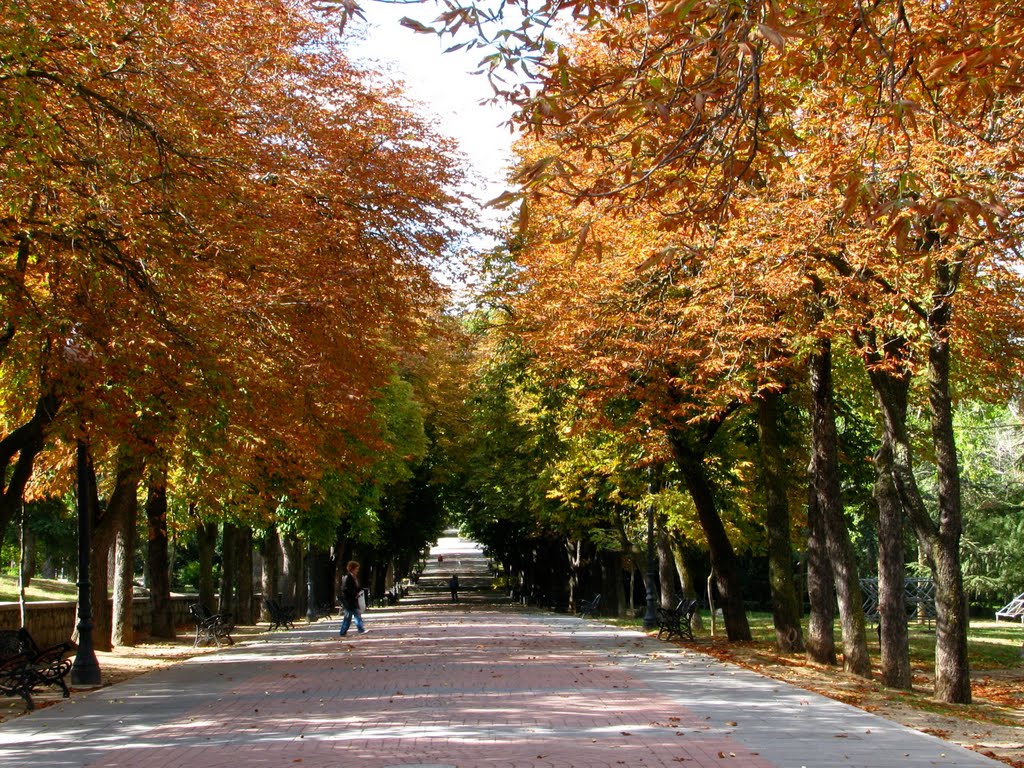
left=351, top=0, right=512, bottom=221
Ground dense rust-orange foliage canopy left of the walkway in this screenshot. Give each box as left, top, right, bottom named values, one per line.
left=0, top=0, right=463, bottom=518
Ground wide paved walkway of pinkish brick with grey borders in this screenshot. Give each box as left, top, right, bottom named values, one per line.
left=0, top=542, right=1001, bottom=768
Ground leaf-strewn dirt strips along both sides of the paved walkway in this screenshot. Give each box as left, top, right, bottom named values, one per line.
left=0, top=625, right=1024, bottom=768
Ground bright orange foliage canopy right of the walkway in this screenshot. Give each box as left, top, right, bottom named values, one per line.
left=501, top=2, right=1024, bottom=419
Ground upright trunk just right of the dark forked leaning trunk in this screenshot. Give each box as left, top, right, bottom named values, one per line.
left=758, top=392, right=804, bottom=653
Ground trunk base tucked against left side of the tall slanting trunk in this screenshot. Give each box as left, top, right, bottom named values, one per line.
left=807, top=486, right=838, bottom=666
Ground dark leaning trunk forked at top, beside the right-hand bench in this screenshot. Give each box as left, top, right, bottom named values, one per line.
left=669, top=421, right=751, bottom=642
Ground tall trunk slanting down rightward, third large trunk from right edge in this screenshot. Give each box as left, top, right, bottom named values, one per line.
left=809, top=339, right=871, bottom=677
